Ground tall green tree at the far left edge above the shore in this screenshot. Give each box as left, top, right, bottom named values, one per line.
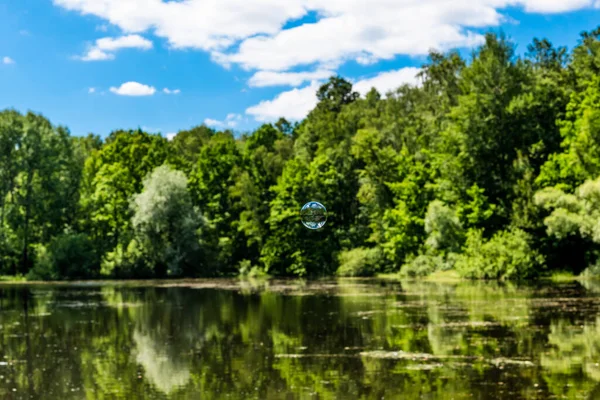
left=0, top=111, right=78, bottom=273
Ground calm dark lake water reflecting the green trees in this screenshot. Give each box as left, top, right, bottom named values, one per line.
left=0, top=280, right=600, bottom=400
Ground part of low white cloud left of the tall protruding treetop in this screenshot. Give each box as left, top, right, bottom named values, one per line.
left=246, top=82, right=319, bottom=122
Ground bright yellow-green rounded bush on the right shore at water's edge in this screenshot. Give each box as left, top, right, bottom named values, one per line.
left=455, top=229, right=544, bottom=280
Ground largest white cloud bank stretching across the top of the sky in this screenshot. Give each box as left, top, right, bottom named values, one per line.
left=53, top=0, right=600, bottom=72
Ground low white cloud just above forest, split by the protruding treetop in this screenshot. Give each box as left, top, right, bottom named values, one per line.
left=246, top=67, right=420, bottom=122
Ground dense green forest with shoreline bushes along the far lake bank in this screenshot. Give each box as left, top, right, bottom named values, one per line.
left=0, top=27, right=600, bottom=280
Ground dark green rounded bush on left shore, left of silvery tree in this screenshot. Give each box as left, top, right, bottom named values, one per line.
left=28, top=233, right=99, bottom=280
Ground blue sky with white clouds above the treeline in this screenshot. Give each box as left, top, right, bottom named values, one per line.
left=0, top=0, right=600, bottom=137
